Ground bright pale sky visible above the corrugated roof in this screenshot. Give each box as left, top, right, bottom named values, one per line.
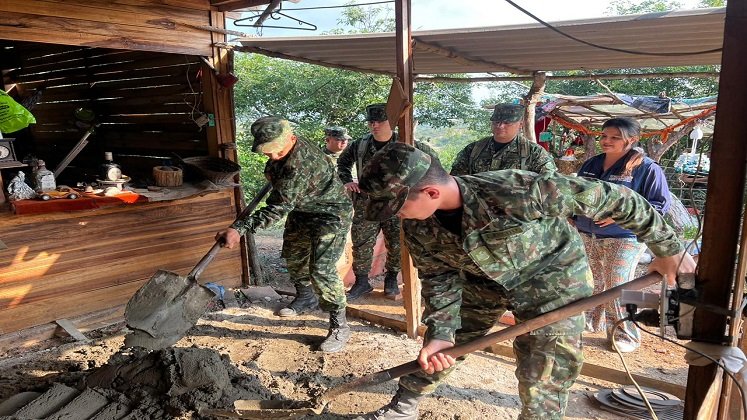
left=229, top=0, right=708, bottom=37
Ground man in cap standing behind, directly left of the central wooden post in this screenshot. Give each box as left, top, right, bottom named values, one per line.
left=337, top=103, right=438, bottom=300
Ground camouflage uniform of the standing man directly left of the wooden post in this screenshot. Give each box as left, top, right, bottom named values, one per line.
left=337, top=132, right=437, bottom=276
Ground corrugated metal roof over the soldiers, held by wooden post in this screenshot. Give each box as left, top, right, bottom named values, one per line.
left=239, top=8, right=725, bottom=74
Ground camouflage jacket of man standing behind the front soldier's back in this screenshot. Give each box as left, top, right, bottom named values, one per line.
left=451, top=134, right=557, bottom=175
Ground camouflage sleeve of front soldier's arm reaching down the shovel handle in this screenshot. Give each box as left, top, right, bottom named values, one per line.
left=405, top=231, right=462, bottom=343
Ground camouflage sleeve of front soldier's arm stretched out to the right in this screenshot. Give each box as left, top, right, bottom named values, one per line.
left=507, top=174, right=683, bottom=257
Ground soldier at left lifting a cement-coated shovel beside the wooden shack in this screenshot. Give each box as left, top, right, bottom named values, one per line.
left=217, top=117, right=352, bottom=352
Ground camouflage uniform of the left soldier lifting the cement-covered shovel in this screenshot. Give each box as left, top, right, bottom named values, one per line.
left=231, top=139, right=352, bottom=311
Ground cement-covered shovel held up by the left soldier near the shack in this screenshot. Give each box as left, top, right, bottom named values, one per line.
left=124, top=184, right=272, bottom=350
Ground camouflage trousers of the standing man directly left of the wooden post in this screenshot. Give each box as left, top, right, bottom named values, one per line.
left=350, top=195, right=402, bottom=276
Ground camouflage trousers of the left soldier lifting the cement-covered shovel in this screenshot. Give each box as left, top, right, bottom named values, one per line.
left=282, top=211, right=350, bottom=312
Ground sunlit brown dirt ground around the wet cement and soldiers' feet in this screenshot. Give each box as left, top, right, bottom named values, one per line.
left=0, top=231, right=687, bottom=420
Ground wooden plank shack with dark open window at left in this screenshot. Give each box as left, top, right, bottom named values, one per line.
left=0, top=0, right=268, bottom=348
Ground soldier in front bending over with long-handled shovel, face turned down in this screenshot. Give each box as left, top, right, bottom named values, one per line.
left=359, top=143, right=695, bottom=420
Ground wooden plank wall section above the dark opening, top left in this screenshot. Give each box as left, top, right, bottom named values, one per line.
left=0, top=0, right=212, bottom=57
